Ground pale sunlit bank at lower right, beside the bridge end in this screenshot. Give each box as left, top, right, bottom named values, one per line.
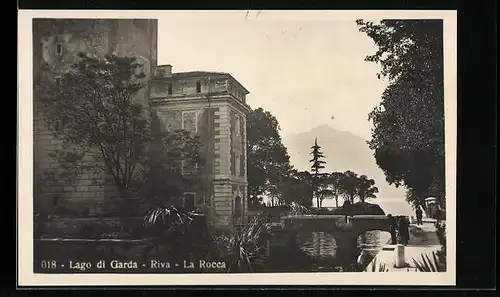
left=366, top=219, right=441, bottom=272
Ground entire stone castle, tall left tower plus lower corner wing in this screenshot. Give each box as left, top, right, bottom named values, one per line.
left=33, top=19, right=250, bottom=229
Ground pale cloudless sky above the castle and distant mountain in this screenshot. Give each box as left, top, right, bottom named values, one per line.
left=158, top=11, right=386, bottom=139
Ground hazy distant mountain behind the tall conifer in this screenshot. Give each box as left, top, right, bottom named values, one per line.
left=282, top=125, right=405, bottom=203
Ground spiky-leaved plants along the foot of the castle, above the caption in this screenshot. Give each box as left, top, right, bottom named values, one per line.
left=144, top=206, right=271, bottom=272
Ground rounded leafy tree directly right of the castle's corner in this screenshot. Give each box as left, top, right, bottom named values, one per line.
left=247, top=108, right=292, bottom=205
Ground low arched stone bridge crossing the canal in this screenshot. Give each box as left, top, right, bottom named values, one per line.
left=283, top=215, right=390, bottom=263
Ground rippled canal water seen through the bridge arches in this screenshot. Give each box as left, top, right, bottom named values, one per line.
left=297, top=231, right=390, bottom=271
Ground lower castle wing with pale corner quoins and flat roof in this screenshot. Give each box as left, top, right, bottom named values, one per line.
left=149, top=65, right=250, bottom=230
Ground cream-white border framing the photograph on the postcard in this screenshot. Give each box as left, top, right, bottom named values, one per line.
left=17, top=10, right=457, bottom=286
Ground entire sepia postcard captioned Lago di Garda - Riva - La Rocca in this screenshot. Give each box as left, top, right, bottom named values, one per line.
left=17, top=10, right=456, bottom=286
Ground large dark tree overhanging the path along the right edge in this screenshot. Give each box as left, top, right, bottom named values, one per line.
left=357, top=20, right=445, bottom=207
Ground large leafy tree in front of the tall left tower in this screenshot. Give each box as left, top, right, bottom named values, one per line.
left=38, top=54, right=150, bottom=208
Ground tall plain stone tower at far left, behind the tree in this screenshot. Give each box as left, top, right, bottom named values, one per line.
left=33, top=19, right=158, bottom=213
